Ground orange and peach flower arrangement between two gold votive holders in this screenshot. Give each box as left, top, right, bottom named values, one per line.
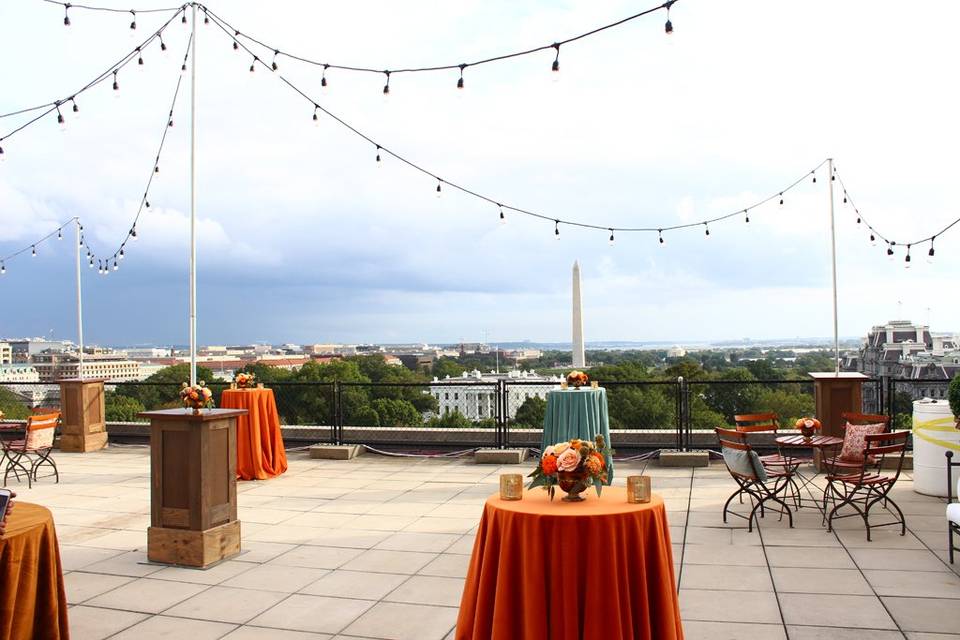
left=527, top=435, right=610, bottom=502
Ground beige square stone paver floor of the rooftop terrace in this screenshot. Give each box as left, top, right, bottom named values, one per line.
left=12, top=446, right=960, bottom=640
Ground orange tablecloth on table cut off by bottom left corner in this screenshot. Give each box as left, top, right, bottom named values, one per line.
left=0, top=501, right=70, bottom=640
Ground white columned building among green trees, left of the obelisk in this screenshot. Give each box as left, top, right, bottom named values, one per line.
left=430, top=370, right=562, bottom=420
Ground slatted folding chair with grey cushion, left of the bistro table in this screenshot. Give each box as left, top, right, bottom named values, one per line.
left=714, top=428, right=796, bottom=531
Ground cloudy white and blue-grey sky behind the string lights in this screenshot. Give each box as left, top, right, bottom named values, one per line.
left=0, top=0, right=960, bottom=344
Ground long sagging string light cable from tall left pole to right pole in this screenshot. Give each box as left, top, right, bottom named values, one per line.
left=210, top=12, right=827, bottom=244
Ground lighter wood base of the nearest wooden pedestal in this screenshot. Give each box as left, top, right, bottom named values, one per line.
left=147, top=520, right=240, bottom=568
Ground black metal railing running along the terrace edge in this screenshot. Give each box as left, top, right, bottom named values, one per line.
left=0, top=378, right=949, bottom=450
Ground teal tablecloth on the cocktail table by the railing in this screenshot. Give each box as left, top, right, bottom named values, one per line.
left=540, top=388, right=613, bottom=484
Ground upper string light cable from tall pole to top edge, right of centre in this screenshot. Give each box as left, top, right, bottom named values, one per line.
left=198, top=0, right=677, bottom=94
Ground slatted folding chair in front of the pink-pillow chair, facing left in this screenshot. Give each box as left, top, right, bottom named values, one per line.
left=823, top=431, right=910, bottom=542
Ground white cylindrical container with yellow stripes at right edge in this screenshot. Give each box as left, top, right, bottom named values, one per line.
left=913, top=398, right=960, bottom=497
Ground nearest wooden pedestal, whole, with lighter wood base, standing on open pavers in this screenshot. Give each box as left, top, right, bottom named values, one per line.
left=140, top=409, right=247, bottom=567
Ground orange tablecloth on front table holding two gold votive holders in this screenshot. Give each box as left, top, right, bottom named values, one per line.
left=456, top=487, right=683, bottom=640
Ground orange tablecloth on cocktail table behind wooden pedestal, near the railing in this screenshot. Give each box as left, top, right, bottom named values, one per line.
left=220, top=389, right=287, bottom=480
